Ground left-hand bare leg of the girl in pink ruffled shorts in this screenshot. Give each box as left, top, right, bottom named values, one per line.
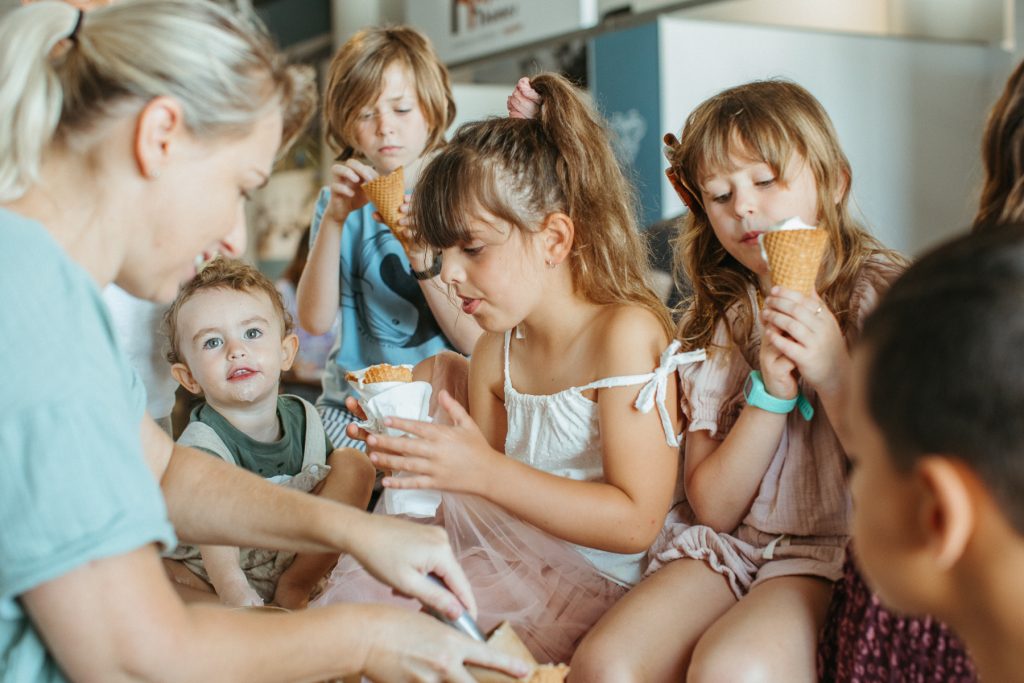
left=569, top=559, right=736, bottom=683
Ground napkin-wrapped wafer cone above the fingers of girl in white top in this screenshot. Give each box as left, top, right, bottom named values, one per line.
left=345, top=365, right=432, bottom=436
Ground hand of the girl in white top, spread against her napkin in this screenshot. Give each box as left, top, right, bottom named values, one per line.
left=367, top=390, right=499, bottom=494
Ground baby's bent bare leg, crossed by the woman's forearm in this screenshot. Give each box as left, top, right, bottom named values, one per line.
left=273, top=449, right=376, bottom=609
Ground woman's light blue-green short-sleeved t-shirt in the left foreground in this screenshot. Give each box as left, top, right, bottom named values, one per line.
left=0, top=209, right=175, bottom=683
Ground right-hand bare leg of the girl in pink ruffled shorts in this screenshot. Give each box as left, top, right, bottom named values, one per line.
left=686, top=577, right=831, bottom=683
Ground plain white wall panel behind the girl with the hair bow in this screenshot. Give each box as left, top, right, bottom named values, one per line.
left=659, top=17, right=1013, bottom=254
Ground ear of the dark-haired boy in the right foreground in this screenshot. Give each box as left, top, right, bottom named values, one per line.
left=915, top=456, right=977, bottom=571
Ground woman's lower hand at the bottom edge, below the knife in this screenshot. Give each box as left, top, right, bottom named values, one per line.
left=362, top=605, right=529, bottom=683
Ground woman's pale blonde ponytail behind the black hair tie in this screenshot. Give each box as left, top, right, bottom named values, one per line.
left=0, top=2, right=80, bottom=202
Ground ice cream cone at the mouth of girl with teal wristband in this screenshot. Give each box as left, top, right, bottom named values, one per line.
left=759, top=218, right=828, bottom=295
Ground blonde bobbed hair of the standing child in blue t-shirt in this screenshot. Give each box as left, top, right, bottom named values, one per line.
left=324, top=26, right=455, bottom=161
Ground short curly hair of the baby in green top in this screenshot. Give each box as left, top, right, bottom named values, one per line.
left=164, top=258, right=294, bottom=365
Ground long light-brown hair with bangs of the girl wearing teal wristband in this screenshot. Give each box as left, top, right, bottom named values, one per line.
left=666, top=80, right=905, bottom=349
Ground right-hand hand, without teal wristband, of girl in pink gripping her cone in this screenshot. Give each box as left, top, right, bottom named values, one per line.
left=762, top=287, right=849, bottom=393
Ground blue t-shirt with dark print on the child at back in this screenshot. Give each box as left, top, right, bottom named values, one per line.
left=309, top=187, right=454, bottom=407
